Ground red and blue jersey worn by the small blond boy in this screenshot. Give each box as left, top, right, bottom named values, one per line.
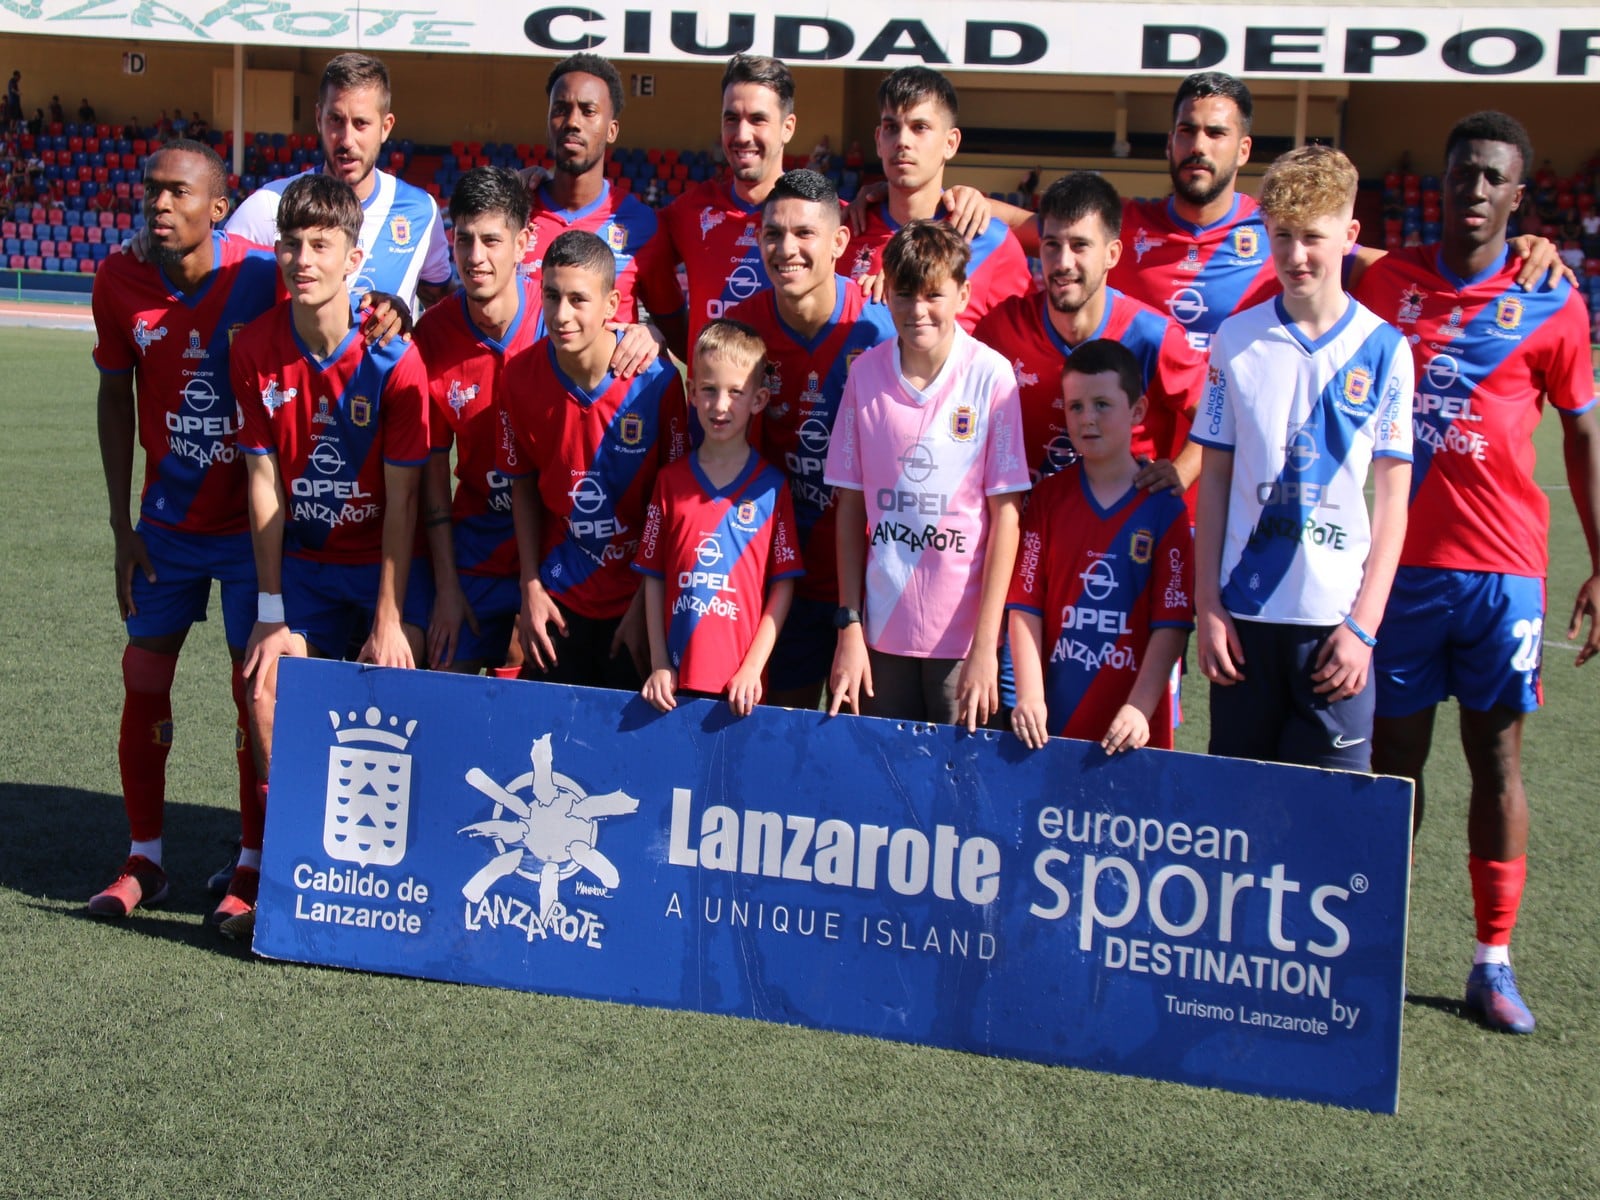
left=634, top=450, right=803, bottom=694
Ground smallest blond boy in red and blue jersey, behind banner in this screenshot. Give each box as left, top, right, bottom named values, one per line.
left=634, top=320, right=805, bottom=717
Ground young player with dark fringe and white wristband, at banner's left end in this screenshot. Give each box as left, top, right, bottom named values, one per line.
left=221, top=174, right=429, bottom=939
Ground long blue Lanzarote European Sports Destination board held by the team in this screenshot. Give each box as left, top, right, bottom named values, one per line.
left=254, top=661, right=1411, bottom=1112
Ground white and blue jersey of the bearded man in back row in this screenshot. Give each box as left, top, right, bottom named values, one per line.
left=227, top=168, right=450, bottom=314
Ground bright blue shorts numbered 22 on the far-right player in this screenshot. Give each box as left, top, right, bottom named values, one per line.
left=1373, top=566, right=1544, bottom=717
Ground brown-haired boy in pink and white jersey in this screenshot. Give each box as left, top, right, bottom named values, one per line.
left=824, top=221, right=1029, bottom=730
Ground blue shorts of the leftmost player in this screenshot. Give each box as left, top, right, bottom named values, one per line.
left=126, top=522, right=256, bottom=650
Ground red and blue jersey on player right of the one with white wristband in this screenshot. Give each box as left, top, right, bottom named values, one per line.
left=416, top=280, right=542, bottom=578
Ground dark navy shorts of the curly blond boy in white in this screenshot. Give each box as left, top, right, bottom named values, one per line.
left=1208, top=618, right=1376, bottom=771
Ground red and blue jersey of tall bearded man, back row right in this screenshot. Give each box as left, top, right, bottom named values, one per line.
left=1107, top=192, right=1280, bottom=352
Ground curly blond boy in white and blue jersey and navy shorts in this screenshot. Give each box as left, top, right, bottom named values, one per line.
left=1190, top=146, right=1413, bottom=771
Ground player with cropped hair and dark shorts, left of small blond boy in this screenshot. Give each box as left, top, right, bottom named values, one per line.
left=496, top=229, right=688, bottom=691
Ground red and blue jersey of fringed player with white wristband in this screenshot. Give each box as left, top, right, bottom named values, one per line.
left=234, top=301, right=427, bottom=565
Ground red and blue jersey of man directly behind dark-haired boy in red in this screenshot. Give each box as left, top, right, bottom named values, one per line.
left=974, top=288, right=1206, bottom=480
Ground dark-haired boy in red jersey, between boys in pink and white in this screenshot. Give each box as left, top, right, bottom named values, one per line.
left=1006, top=339, right=1194, bottom=754
